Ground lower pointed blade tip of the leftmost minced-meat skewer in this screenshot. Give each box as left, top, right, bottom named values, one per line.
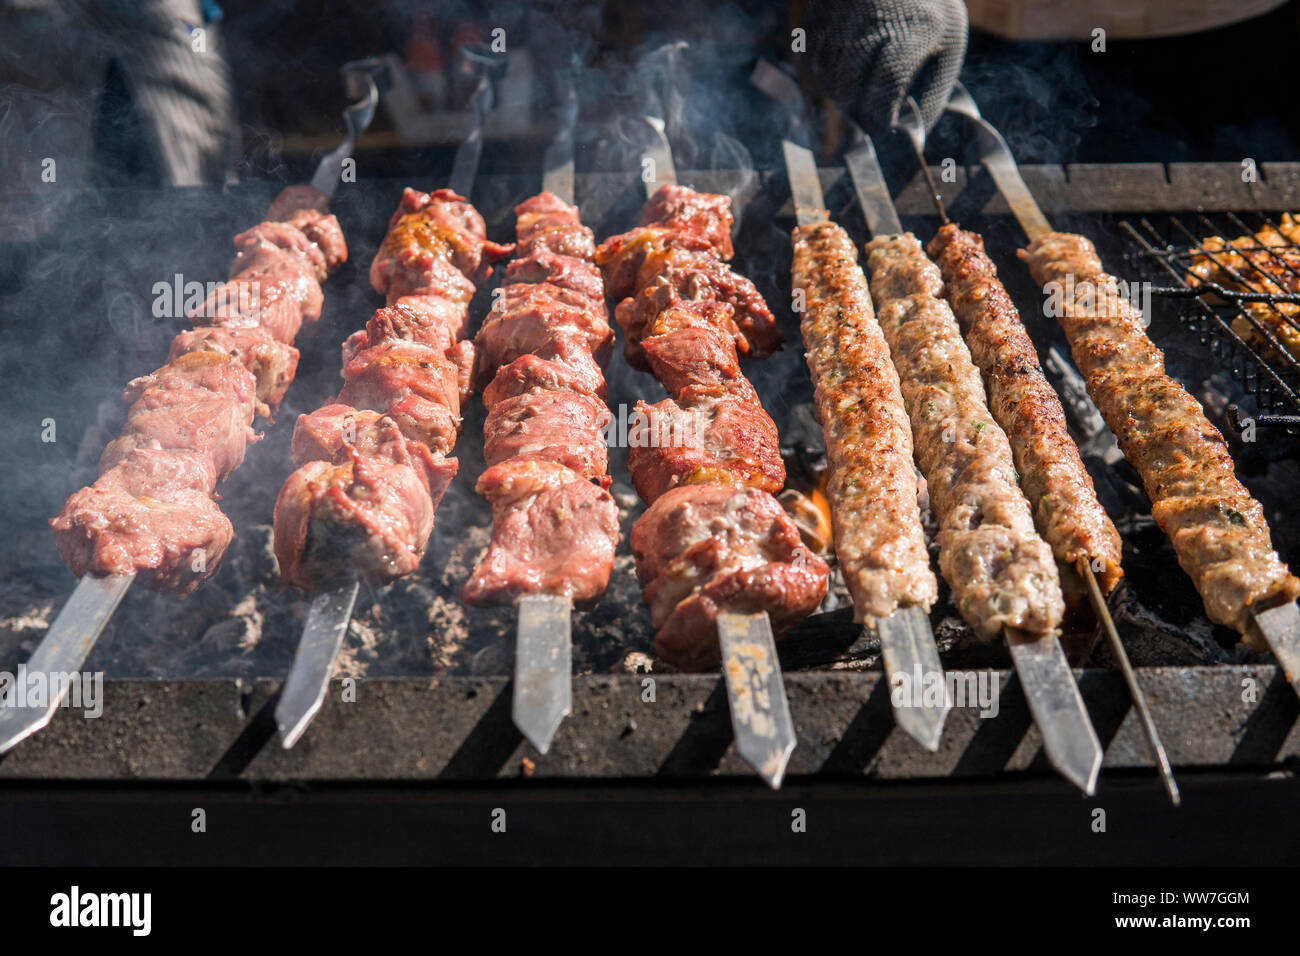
left=876, top=607, right=953, bottom=753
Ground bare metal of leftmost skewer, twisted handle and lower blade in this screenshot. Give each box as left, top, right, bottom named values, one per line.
left=0, top=60, right=382, bottom=753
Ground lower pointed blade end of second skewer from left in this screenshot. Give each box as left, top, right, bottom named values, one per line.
left=276, top=579, right=360, bottom=750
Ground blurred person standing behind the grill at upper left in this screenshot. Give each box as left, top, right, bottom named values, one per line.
left=0, top=0, right=239, bottom=239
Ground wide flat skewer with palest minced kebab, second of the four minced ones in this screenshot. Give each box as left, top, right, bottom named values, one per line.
left=845, top=139, right=1102, bottom=795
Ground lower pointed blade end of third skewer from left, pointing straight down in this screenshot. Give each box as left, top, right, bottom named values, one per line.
left=512, top=594, right=573, bottom=753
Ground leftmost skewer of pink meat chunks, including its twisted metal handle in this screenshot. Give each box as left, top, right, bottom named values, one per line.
left=0, top=61, right=378, bottom=753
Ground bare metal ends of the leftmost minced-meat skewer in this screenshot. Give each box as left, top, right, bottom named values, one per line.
left=781, top=140, right=953, bottom=750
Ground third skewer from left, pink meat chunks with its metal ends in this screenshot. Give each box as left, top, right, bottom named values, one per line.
left=462, top=100, right=619, bottom=753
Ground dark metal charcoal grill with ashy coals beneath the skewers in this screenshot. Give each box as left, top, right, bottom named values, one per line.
left=0, top=164, right=1300, bottom=795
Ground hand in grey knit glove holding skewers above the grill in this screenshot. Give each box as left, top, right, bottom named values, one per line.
left=806, top=0, right=967, bottom=137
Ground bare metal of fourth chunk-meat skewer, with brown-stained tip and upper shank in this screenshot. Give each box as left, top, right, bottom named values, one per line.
left=642, top=116, right=796, bottom=790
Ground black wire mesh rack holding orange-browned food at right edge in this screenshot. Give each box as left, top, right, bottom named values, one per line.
left=1119, top=212, right=1300, bottom=434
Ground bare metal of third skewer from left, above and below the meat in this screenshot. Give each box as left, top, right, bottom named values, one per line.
left=511, top=85, right=577, bottom=753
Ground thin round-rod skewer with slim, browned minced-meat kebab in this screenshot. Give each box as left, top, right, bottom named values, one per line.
left=898, top=98, right=1180, bottom=806
